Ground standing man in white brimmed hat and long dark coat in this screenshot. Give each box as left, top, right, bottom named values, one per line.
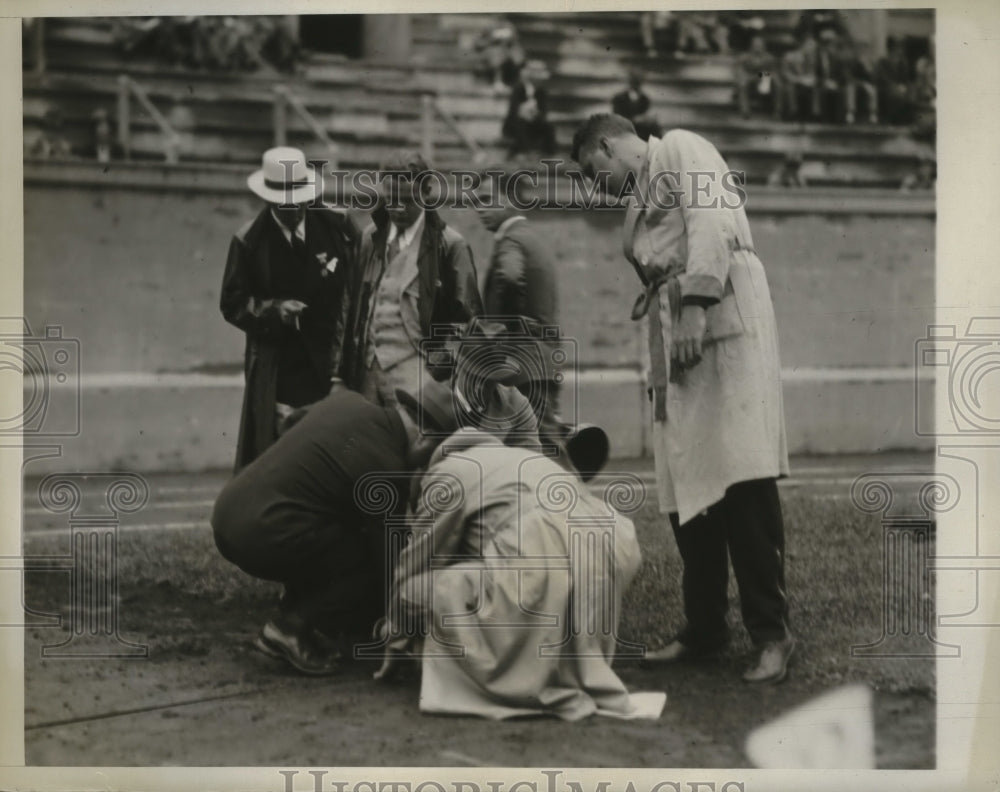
left=220, top=147, right=358, bottom=470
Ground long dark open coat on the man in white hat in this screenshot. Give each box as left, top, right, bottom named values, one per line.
left=219, top=207, right=358, bottom=470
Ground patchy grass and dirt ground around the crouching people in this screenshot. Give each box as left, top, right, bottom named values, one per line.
left=19, top=464, right=935, bottom=767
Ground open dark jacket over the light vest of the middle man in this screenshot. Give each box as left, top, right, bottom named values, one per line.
left=335, top=205, right=483, bottom=390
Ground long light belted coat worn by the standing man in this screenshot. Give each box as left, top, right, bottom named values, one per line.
left=623, top=129, right=789, bottom=524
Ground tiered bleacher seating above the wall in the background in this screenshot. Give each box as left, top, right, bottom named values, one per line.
left=24, top=10, right=934, bottom=189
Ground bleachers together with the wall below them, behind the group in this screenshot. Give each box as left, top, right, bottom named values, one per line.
left=17, top=10, right=936, bottom=470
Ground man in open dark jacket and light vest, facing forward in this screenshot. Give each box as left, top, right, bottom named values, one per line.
left=340, top=150, right=482, bottom=407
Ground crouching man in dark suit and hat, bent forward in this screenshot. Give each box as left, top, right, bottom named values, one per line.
left=212, top=379, right=456, bottom=675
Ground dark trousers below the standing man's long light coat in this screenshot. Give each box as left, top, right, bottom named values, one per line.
left=670, top=478, right=788, bottom=649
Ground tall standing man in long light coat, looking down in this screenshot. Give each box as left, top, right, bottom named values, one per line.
left=573, top=114, right=795, bottom=682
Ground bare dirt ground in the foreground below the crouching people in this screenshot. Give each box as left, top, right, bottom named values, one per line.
left=25, top=575, right=935, bottom=768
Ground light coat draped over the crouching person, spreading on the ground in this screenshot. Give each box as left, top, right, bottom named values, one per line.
left=389, top=430, right=666, bottom=720
